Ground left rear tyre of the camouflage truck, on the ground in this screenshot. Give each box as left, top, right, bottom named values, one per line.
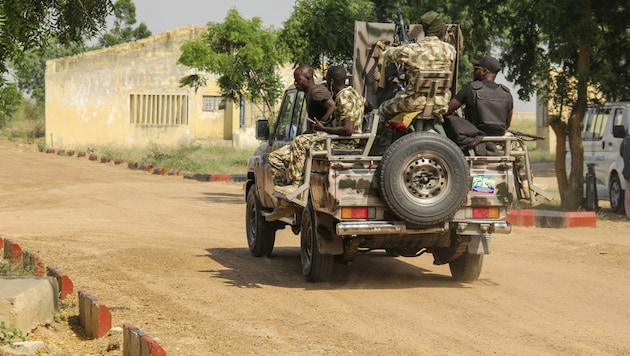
left=300, top=202, right=335, bottom=282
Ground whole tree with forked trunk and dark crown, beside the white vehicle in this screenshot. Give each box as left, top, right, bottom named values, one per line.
left=490, top=0, right=630, bottom=210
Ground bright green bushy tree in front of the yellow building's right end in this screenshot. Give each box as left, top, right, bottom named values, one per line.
left=178, top=9, right=286, bottom=115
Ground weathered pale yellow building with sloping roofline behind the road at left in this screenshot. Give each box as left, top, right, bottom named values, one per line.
left=46, top=26, right=287, bottom=149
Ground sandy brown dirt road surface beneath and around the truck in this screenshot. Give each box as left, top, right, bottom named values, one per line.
left=0, top=142, right=630, bottom=355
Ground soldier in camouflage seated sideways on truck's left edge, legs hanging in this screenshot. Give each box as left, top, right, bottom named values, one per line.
left=270, top=66, right=365, bottom=195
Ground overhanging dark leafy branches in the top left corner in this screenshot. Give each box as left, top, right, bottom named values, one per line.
left=0, top=0, right=112, bottom=85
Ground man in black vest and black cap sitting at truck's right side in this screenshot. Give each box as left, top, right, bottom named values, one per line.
left=445, top=56, right=514, bottom=136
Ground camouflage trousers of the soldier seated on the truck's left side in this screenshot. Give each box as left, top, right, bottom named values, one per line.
left=269, top=132, right=326, bottom=184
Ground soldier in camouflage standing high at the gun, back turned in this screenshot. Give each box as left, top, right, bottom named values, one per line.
left=377, top=11, right=456, bottom=121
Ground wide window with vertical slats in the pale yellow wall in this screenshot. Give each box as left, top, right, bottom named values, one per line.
left=129, top=94, right=188, bottom=126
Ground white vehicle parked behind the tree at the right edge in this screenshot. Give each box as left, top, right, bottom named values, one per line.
left=582, top=101, right=630, bottom=213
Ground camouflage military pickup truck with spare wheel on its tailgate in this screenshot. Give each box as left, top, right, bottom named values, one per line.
left=245, top=19, right=550, bottom=282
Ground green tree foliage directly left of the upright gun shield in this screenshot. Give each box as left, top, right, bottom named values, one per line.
left=280, top=0, right=376, bottom=68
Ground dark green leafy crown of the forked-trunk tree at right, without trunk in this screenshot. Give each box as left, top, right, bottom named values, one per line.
left=496, top=0, right=630, bottom=108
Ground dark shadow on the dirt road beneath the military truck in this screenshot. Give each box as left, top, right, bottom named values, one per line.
left=201, top=247, right=484, bottom=290
